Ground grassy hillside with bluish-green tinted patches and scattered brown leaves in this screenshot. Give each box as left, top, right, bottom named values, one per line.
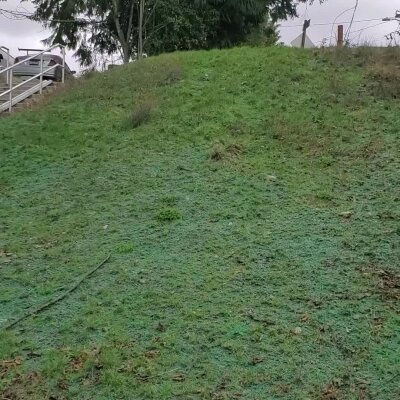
left=0, top=48, right=400, bottom=400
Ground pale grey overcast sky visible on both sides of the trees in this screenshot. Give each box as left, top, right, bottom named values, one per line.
left=0, top=0, right=400, bottom=69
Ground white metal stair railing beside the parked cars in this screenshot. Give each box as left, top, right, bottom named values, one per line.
left=0, top=44, right=65, bottom=112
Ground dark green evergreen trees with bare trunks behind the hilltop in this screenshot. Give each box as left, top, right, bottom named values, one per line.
left=33, top=0, right=318, bottom=65
